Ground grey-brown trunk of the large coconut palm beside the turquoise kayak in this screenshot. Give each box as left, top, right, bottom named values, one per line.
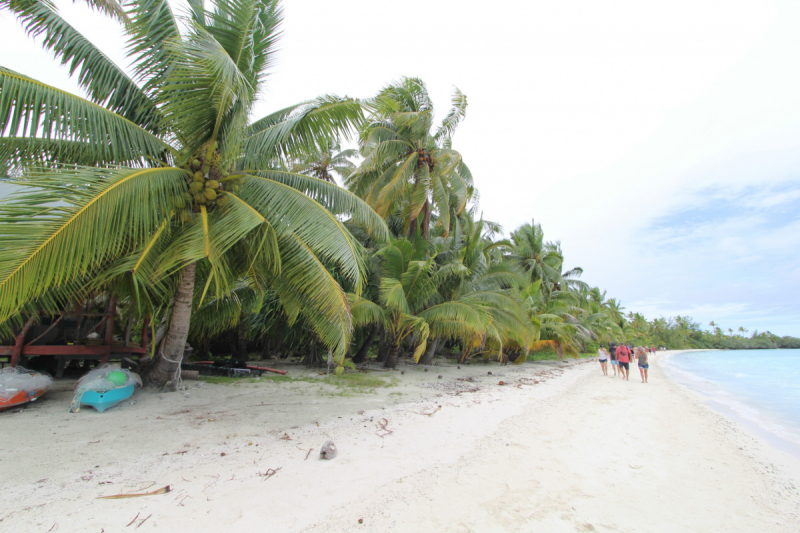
left=145, top=263, right=197, bottom=388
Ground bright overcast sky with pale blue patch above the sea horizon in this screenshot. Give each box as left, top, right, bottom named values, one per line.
left=0, top=0, right=800, bottom=336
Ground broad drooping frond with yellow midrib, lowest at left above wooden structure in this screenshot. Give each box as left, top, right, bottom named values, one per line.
left=0, top=168, right=186, bottom=321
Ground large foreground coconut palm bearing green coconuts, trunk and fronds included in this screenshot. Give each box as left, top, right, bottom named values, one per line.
left=0, top=0, right=388, bottom=385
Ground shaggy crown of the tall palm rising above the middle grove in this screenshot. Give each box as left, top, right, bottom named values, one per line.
left=347, top=78, right=473, bottom=238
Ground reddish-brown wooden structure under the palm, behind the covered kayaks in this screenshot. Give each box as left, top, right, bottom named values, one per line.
left=0, top=296, right=149, bottom=377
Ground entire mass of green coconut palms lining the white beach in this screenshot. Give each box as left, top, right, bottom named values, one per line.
left=0, top=0, right=800, bottom=384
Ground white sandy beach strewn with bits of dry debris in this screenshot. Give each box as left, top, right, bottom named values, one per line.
left=0, top=356, right=800, bottom=533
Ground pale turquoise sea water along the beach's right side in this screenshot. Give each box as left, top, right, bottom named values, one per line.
left=663, top=350, right=800, bottom=457
